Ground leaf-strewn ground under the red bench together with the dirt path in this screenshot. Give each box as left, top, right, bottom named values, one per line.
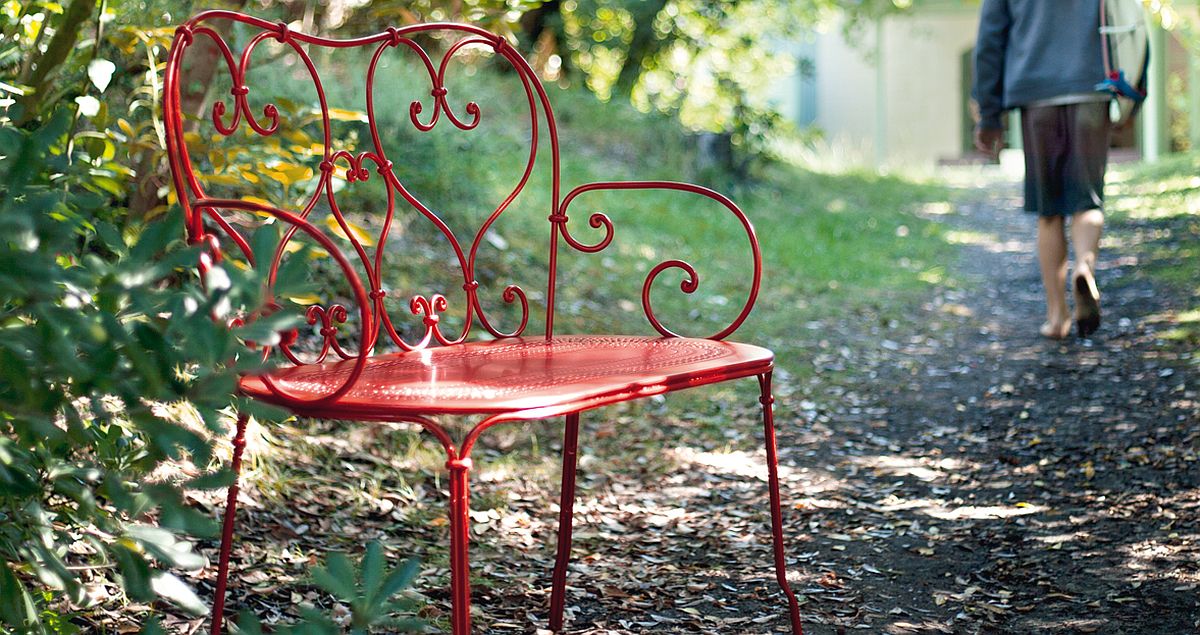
left=184, top=172, right=1200, bottom=635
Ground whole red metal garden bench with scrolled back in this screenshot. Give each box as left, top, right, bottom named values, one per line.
left=163, top=11, right=802, bottom=635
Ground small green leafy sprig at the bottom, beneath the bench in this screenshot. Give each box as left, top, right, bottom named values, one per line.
left=229, top=541, right=427, bottom=635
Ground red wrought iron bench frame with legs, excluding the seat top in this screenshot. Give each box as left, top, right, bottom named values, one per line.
left=163, top=11, right=802, bottom=635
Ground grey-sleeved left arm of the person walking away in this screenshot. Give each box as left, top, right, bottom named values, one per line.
left=971, top=0, right=1013, bottom=154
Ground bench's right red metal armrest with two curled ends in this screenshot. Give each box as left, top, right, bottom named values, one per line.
left=551, top=181, right=762, bottom=340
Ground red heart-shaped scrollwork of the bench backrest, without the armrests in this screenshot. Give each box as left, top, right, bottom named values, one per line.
left=163, top=16, right=556, bottom=355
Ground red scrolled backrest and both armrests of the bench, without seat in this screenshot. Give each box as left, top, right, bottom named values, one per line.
left=164, top=11, right=762, bottom=410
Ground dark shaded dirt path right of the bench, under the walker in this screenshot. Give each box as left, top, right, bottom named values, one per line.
left=772, top=174, right=1200, bottom=635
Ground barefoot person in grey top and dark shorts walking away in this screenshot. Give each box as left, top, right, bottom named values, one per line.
left=972, top=0, right=1111, bottom=339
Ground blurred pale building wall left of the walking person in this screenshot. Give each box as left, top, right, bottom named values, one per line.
left=774, top=8, right=978, bottom=164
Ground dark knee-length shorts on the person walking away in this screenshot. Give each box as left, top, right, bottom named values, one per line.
left=1021, top=101, right=1109, bottom=216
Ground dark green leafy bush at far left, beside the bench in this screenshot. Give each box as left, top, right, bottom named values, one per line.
left=0, top=112, right=263, bottom=630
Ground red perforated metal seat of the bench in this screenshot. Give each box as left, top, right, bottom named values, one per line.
left=241, top=335, right=774, bottom=419
